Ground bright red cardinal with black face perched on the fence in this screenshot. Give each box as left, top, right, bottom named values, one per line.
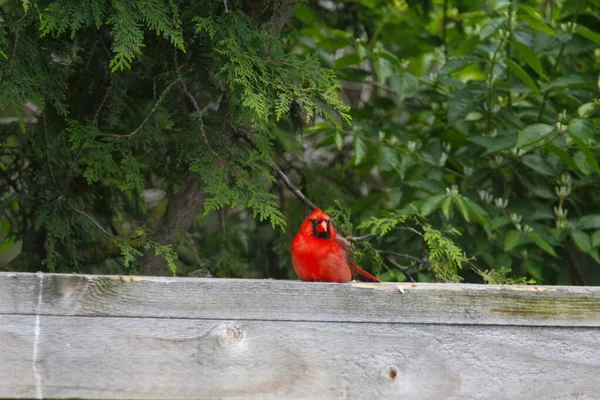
left=290, top=208, right=381, bottom=282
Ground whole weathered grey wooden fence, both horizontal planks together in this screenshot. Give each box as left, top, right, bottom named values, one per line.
left=0, top=273, right=600, bottom=400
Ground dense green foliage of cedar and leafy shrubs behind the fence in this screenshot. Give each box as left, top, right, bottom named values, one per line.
left=0, top=0, right=600, bottom=285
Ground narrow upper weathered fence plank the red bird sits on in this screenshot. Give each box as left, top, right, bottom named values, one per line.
left=0, top=273, right=600, bottom=327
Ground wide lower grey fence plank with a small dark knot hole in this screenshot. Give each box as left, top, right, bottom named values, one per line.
left=0, top=315, right=600, bottom=400
